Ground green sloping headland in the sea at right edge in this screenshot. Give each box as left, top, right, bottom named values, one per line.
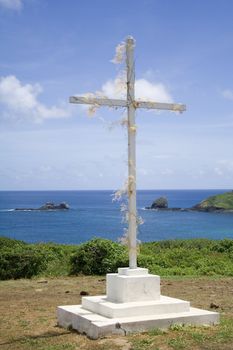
left=194, top=191, right=233, bottom=211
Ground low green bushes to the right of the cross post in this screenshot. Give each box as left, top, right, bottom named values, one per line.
left=138, top=239, right=233, bottom=276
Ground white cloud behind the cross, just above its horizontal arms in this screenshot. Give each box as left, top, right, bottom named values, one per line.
left=100, top=76, right=172, bottom=102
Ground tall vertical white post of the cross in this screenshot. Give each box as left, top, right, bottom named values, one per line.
left=126, top=37, right=137, bottom=269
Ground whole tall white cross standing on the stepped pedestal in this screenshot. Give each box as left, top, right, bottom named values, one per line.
left=70, top=37, right=186, bottom=269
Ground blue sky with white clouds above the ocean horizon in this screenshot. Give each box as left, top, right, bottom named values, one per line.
left=0, top=0, right=233, bottom=190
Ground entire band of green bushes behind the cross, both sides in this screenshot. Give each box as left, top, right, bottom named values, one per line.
left=0, top=237, right=233, bottom=280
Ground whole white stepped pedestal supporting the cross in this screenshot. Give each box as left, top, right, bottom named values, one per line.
left=57, top=268, right=219, bottom=339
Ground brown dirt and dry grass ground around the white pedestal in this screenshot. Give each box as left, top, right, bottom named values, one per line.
left=0, top=276, right=233, bottom=350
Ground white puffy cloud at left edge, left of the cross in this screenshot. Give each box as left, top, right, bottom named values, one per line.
left=0, top=75, right=70, bottom=122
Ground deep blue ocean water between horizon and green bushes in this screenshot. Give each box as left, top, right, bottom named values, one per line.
left=0, top=190, right=233, bottom=244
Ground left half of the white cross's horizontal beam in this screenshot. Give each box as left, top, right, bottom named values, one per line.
left=70, top=96, right=127, bottom=107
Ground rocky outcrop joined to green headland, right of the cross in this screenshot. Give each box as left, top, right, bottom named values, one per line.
left=145, top=191, right=233, bottom=212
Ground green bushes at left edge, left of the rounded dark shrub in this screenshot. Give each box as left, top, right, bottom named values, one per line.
left=0, top=237, right=75, bottom=280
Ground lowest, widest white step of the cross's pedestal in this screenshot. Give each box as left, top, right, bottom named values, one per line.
left=57, top=305, right=219, bottom=339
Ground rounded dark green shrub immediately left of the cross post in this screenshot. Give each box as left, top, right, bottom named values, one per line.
left=71, top=238, right=128, bottom=275
